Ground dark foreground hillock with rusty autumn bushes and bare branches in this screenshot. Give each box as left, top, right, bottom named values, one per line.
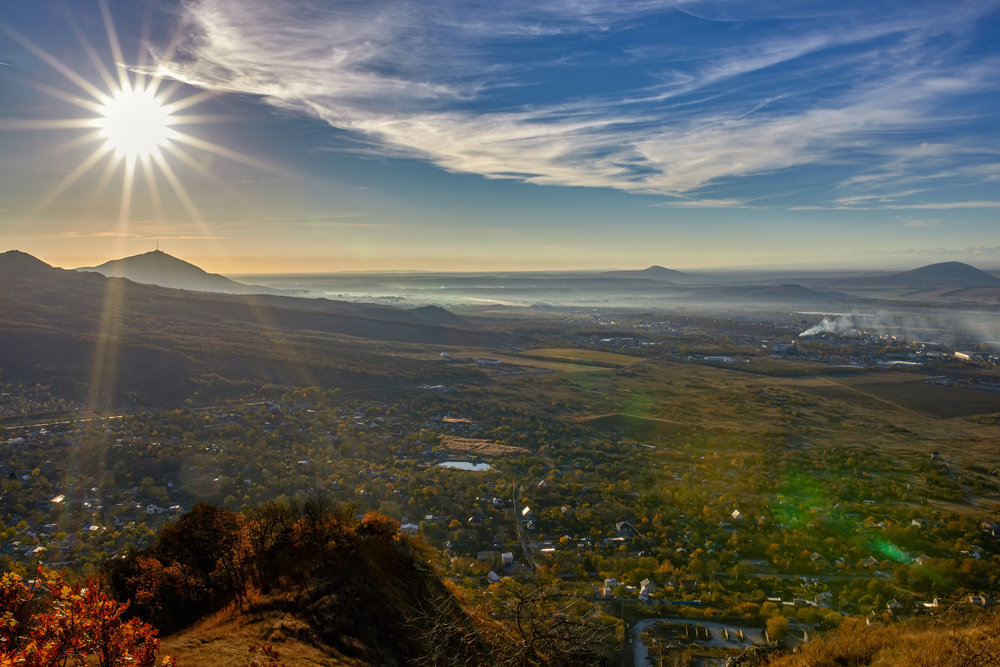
left=105, top=500, right=607, bottom=665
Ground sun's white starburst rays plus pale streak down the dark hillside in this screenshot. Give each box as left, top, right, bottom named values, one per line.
left=0, top=0, right=274, bottom=324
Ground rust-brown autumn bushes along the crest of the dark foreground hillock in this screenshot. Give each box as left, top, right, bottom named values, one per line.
left=104, top=498, right=417, bottom=632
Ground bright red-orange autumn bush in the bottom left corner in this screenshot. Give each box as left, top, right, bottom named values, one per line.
left=0, top=566, right=174, bottom=667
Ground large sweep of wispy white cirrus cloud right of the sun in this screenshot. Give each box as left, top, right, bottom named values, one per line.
left=162, top=0, right=1000, bottom=208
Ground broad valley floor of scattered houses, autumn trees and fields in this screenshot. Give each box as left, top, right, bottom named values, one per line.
left=0, top=316, right=1000, bottom=664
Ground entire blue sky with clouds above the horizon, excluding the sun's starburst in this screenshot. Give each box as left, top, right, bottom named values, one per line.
left=0, top=0, right=1000, bottom=272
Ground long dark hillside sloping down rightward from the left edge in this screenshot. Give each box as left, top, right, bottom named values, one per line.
left=0, top=252, right=496, bottom=409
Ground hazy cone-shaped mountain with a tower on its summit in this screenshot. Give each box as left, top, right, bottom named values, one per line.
left=76, top=250, right=276, bottom=294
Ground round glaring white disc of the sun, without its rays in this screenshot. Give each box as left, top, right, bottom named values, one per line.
left=98, top=89, right=172, bottom=160
